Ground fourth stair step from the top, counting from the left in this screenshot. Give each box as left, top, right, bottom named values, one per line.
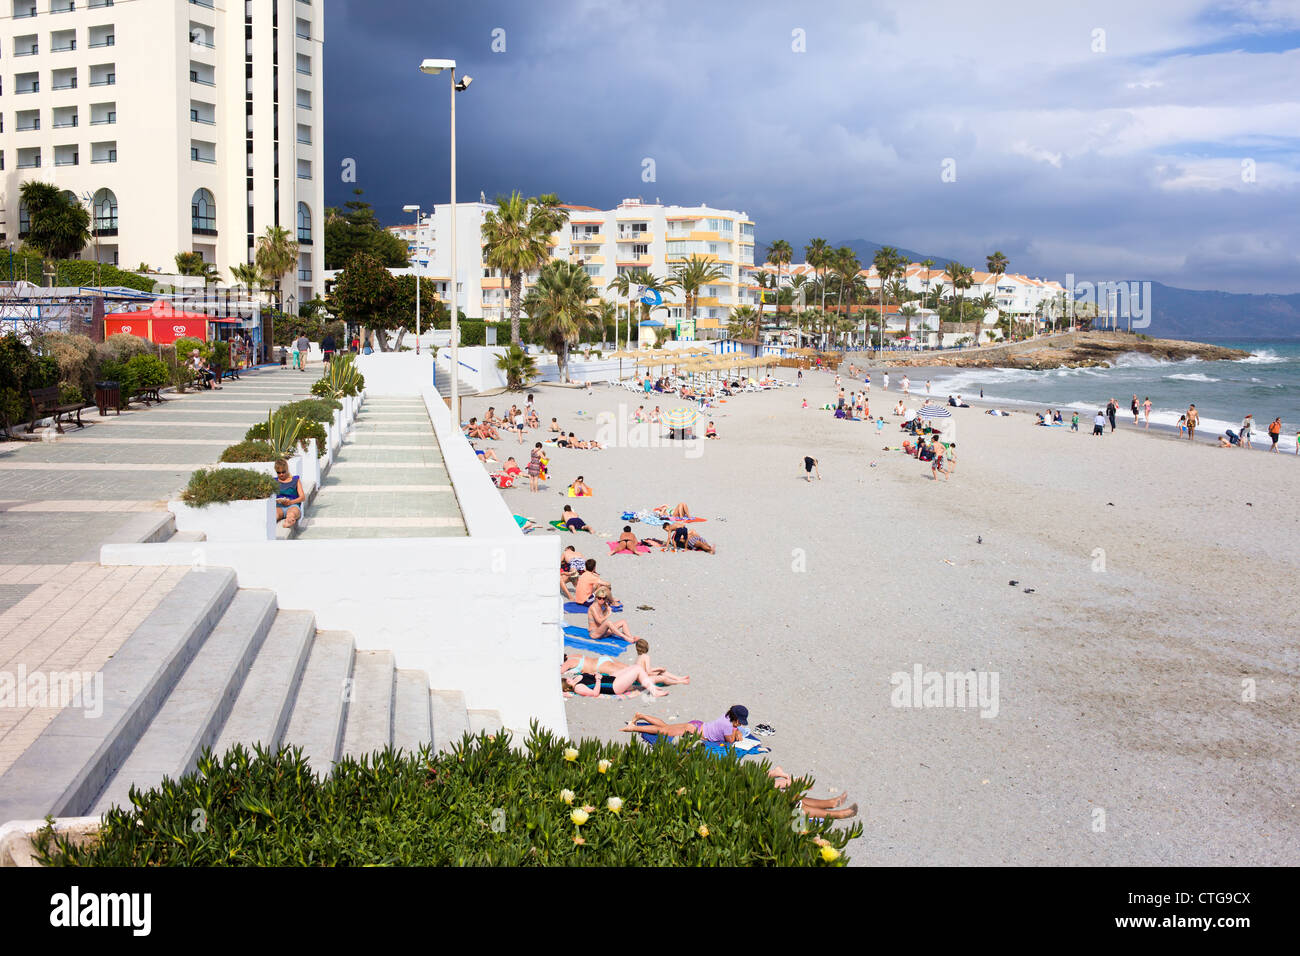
left=285, top=631, right=354, bottom=775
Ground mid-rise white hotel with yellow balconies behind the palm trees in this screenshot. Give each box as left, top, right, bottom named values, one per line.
left=379, top=199, right=758, bottom=338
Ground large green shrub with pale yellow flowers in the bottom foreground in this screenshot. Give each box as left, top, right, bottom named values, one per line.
left=36, top=723, right=862, bottom=866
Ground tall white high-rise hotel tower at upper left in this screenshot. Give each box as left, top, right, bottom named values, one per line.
left=0, top=0, right=325, bottom=304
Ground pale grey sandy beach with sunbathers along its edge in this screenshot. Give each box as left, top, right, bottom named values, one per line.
left=464, top=372, right=1300, bottom=866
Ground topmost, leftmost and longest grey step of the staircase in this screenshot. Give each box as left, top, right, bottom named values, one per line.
left=0, top=567, right=235, bottom=821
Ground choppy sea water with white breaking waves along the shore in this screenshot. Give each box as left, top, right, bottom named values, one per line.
left=925, top=339, right=1300, bottom=453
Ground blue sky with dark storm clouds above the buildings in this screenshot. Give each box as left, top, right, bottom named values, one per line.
left=325, top=0, right=1300, bottom=293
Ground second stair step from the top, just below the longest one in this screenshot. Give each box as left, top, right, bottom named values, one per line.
left=92, top=589, right=276, bottom=813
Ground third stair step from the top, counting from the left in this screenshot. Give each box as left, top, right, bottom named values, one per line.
left=213, top=611, right=316, bottom=754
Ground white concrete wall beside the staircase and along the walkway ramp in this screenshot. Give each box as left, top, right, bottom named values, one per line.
left=100, top=374, right=568, bottom=741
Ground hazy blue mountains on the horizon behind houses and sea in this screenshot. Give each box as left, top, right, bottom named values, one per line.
left=754, top=239, right=1300, bottom=339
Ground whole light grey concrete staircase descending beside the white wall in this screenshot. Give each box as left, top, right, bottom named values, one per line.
left=0, top=567, right=502, bottom=823
